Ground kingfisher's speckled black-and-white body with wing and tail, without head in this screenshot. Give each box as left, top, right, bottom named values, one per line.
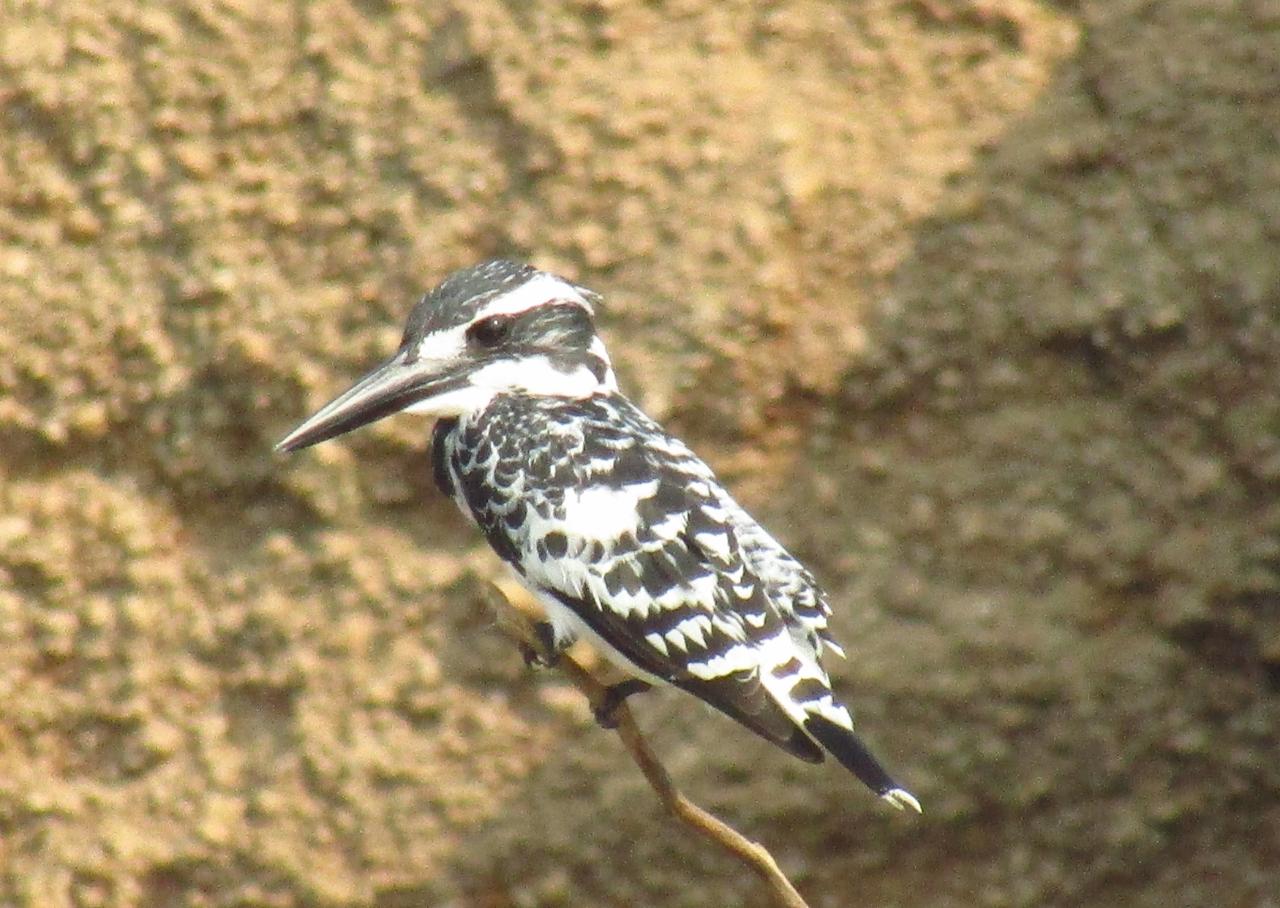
left=435, top=394, right=916, bottom=799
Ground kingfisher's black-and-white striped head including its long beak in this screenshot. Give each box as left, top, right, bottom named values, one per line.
left=275, top=261, right=617, bottom=451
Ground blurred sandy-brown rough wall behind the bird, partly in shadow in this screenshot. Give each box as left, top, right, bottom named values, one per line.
left=0, top=0, right=1280, bottom=908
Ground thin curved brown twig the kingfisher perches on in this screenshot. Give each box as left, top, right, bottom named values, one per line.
left=485, top=583, right=809, bottom=908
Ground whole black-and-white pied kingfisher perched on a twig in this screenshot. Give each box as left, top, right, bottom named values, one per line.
left=276, top=261, right=920, bottom=811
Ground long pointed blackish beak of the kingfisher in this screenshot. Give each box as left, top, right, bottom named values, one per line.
left=275, top=351, right=471, bottom=451
